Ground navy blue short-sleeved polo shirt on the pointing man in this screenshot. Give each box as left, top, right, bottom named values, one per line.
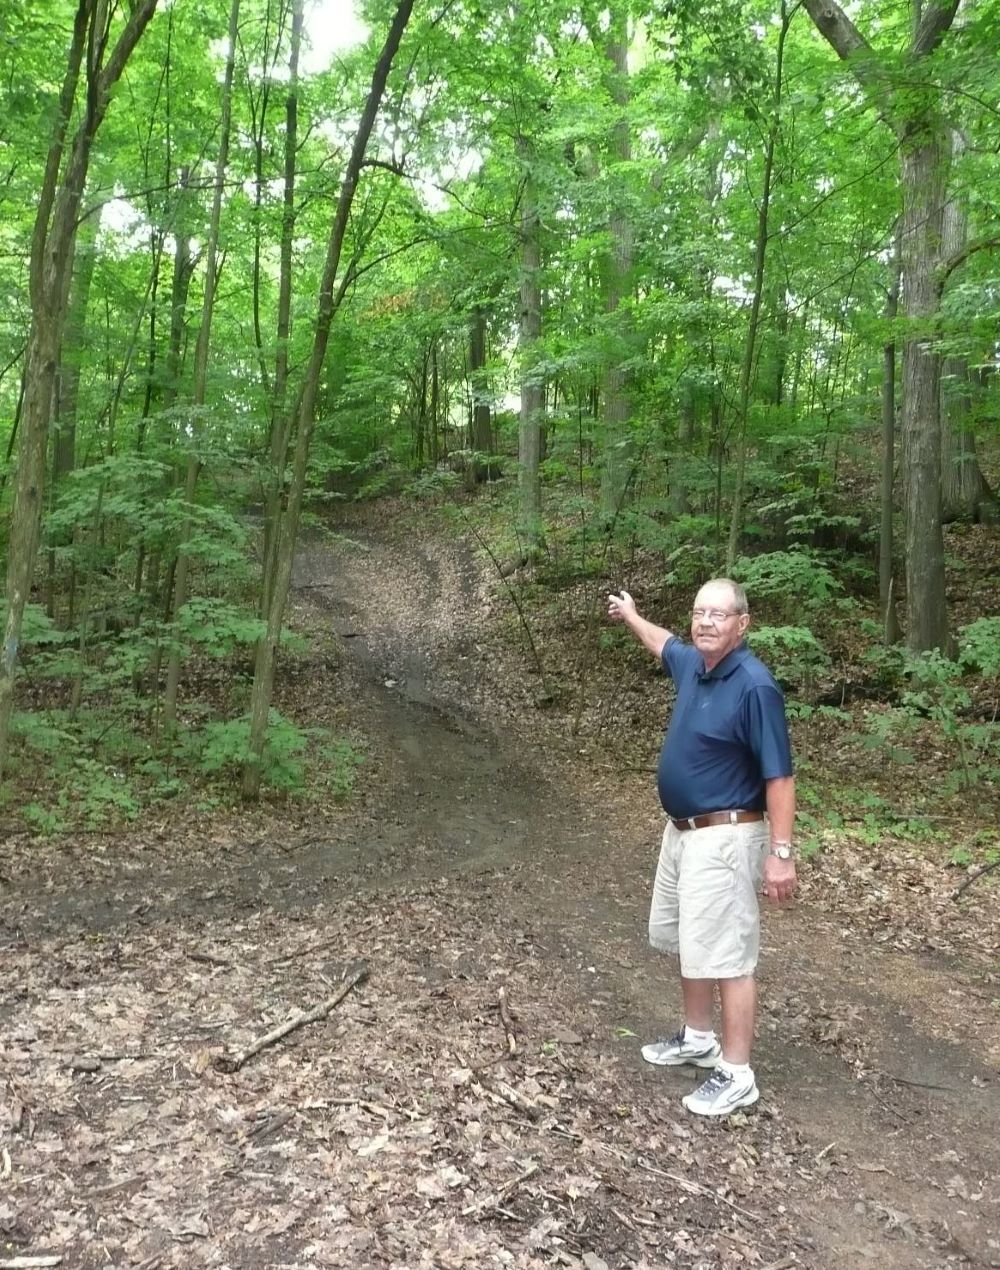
left=657, top=635, right=792, bottom=818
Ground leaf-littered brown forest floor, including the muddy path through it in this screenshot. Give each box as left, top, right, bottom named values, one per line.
left=0, top=505, right=1000, bottom=1270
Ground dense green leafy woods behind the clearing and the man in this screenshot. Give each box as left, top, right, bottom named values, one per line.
left=0, top=0, right=1000, bottom=823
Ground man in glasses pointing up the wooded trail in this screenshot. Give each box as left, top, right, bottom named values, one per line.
left=607, top=578, right=795, bottom=1116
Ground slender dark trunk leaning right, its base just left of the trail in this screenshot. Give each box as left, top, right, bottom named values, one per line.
left=243, top=0, right=413, bottom=799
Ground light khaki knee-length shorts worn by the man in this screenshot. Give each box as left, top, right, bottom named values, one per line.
left=649, top=820, right=769, bottom=979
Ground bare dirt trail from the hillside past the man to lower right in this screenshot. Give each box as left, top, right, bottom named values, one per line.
left=294, top=520, right=1000, bottom=1270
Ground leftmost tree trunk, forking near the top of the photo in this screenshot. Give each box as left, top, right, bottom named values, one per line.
left=0, top=0, right=156, bottom=771
